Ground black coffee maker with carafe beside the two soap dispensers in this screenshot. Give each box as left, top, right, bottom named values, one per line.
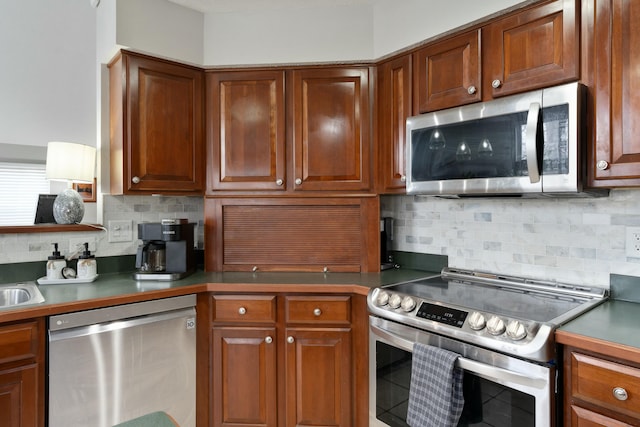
left=133, top=219, right=196, bottom=280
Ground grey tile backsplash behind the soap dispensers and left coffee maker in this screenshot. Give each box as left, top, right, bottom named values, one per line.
left=0, top=195, right=204, bottom=264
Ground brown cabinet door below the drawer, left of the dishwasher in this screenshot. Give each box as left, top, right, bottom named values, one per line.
left=0, top=364, right=38, bottom=427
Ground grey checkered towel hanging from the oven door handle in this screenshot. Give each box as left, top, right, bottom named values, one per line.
left=407, top=343, right=464, bottom=427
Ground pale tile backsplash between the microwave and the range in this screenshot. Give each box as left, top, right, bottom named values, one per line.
left=381, top=190, right=640, bottom=288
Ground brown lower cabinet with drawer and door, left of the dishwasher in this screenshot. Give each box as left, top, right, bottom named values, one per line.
left=0, top=319, right=44, bottom=427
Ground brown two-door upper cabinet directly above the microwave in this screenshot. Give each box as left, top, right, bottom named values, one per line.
left=414, top=0, right=580, bottom=113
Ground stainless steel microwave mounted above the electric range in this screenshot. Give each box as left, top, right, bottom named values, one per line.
left=406, top=83, right=608, bottom=197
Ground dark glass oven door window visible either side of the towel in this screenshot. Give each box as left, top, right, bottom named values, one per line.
left=376, top=341, right=535, bottom=427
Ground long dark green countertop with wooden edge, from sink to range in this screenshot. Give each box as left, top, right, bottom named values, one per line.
left=0, top=269, right=439, bottom=323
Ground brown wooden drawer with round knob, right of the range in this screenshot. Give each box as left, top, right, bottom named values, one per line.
left=571, top=353, right=640, bottom=418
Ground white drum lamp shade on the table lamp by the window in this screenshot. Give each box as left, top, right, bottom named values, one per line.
left=45, top=141, right=96, bottom=183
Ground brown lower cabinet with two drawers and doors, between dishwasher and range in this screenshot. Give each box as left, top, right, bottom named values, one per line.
left=209, top=294, right=368, bottom=427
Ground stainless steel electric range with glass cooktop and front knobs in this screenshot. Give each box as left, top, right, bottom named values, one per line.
left=368, top=268, right=608, bottom=427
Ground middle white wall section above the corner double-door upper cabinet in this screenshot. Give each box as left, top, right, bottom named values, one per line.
left=204, top=5, right=373, bottom=65
